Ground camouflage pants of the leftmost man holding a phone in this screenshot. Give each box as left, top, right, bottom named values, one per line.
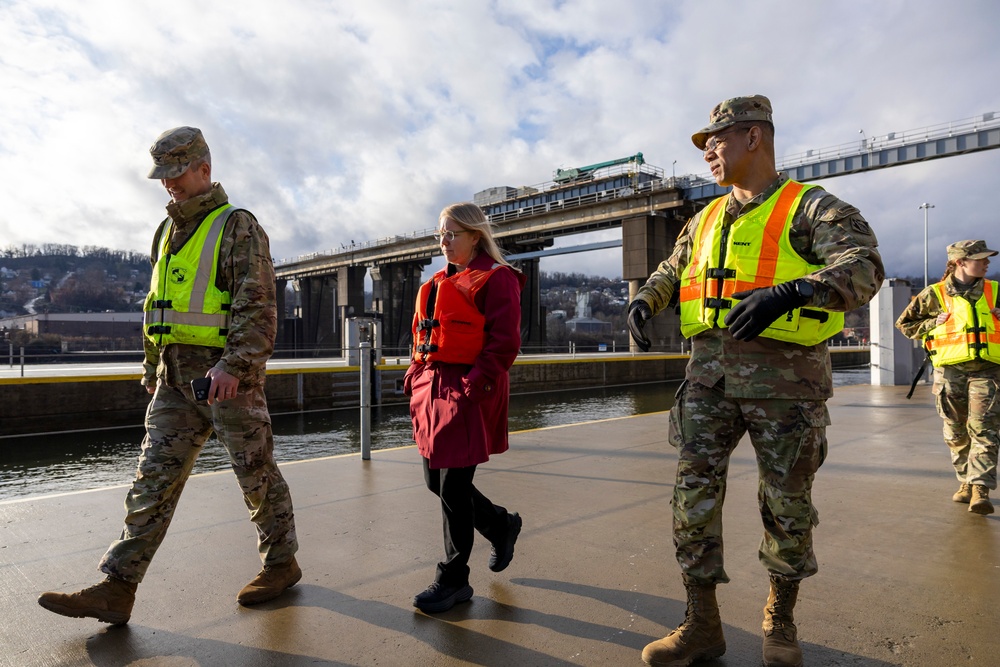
left=100, top=383, right=298, bottom=583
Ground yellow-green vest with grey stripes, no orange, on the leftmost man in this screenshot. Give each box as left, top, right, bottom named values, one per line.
left=143, top=204, right=236, bottom=347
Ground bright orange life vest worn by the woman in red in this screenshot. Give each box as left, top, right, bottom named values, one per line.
left=413, top=263, right=503, bottom=365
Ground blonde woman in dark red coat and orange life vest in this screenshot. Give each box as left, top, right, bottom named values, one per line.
left=403, top=203, right=525, bottom=613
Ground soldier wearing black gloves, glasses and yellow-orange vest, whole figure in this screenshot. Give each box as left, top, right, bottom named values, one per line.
left=627, top=95, right=884, bottom=666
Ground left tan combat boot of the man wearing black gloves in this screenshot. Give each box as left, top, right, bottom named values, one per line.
left=642, top=584, right=726, bottom=667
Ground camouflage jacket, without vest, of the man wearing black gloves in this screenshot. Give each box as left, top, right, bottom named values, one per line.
left=636, top=174, right=885, bottom=399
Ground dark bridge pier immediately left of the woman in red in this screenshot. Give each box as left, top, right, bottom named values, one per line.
left=371, top=259, right=430, bottom=357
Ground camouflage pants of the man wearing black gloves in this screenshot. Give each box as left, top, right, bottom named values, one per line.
left=669, top=381, right=830, bottom=585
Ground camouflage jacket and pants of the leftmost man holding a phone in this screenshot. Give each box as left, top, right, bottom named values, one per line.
left=100, top=183, right=298, bottom=583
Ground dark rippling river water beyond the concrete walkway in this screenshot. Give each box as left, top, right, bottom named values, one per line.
left=0, top=369, right=869, bottom=501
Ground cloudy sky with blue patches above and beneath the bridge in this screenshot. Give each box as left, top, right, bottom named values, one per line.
left=0, top=0, right=1000, bottom=276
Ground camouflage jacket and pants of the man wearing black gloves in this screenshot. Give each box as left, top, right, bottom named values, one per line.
left=636, top=175, right=884, bottom=585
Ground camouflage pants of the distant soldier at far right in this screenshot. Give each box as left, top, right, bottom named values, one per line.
left=934, top=364, right=1000, bottom=489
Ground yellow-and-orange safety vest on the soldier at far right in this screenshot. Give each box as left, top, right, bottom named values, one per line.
left=924, top=280, right=1000, bottom=366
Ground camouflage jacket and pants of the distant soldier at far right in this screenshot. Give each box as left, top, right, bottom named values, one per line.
left=896, top=276, right=1000, bottom=489
